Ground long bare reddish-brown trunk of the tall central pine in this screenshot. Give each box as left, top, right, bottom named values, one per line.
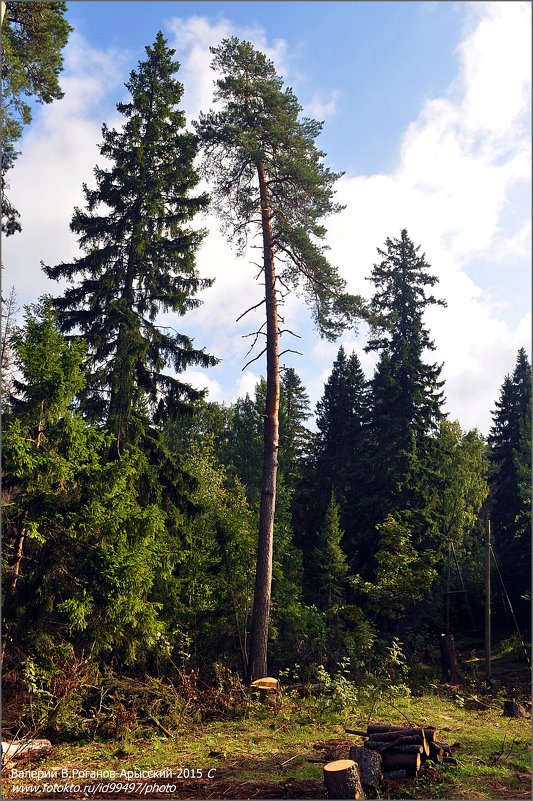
left=247, top=163, right=280, bottom=682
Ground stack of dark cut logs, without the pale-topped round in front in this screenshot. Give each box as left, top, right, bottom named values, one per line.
left=346, top=723, right=458, bottom=789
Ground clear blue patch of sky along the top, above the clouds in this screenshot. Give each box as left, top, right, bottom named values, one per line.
left=68, top=0, right=462, bottom=173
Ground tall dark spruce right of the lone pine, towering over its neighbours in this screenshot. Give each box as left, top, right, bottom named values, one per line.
left=365, top=229, right=446, bottom=540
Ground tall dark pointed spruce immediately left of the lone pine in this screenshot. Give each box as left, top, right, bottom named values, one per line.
left=44, top=33, right=215, bottom=454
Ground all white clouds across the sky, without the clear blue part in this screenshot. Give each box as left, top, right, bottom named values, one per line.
left=3, top=2, right=531, bottom=432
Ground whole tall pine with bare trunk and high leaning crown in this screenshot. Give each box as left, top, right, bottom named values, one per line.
left=197, top=38, right=361, bottom=678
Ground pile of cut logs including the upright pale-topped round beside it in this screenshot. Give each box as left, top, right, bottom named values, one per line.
left=324, top=723, right=457, bottom=798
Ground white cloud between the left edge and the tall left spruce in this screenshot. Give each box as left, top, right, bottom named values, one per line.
left=3, top=32, right=127, bottom=303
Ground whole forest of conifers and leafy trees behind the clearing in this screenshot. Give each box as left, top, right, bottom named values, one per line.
left=1, top=3, right=531, bottom=744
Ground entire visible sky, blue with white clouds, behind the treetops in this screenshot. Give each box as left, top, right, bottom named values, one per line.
left=3, top=1, right=531, bottom=433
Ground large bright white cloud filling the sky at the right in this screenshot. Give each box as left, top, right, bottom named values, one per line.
left=322, top=3, right=531, bottom=432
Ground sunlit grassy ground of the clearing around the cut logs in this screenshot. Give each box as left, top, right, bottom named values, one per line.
left=4, top=687, right=531, bottom=799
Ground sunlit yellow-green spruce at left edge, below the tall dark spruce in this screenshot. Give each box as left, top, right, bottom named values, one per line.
left=2, top=303, right=172, bottom=663
